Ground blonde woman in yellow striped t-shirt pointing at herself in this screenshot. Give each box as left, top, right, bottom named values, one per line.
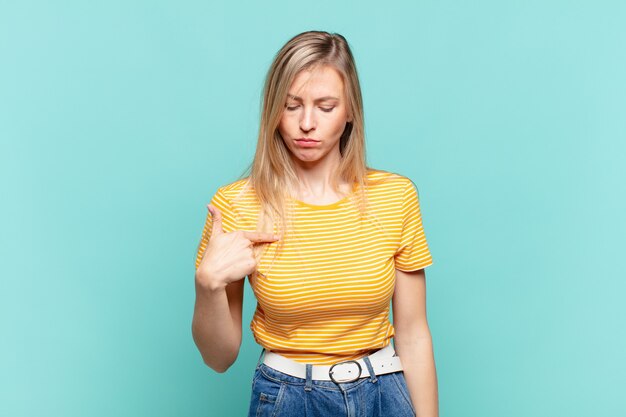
left=192, top=31, right=438, bottom=417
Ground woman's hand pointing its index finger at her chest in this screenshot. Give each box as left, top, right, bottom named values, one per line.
left=196, top=204, right=278, bottom=290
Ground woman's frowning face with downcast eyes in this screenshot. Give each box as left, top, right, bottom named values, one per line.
left=278, top=66, right=350, bottom=166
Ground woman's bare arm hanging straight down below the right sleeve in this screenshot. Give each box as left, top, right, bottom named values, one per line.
left=392, top=269, right=439, bottom=417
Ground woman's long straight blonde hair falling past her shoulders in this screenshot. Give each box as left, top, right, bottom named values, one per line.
left=236, top=31, right=369, bottom=252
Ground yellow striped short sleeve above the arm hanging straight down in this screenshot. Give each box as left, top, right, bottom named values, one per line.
left=395, top=180, right=433, bottom=272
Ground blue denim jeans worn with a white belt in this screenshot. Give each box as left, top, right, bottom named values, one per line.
left=248, top=354, right=415, bottom=417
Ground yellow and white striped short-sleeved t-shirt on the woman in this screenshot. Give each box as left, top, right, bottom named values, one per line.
left=196, top=170, right=433, bottom=364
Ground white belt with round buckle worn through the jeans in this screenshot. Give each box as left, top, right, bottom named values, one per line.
left=263, top=343, right=402, bottom=383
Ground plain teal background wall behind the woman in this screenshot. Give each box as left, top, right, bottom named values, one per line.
left=0, top=0, right=626, bottom=417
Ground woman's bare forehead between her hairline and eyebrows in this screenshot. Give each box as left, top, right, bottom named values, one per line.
left=288, top=65, right=344, bottom=99
